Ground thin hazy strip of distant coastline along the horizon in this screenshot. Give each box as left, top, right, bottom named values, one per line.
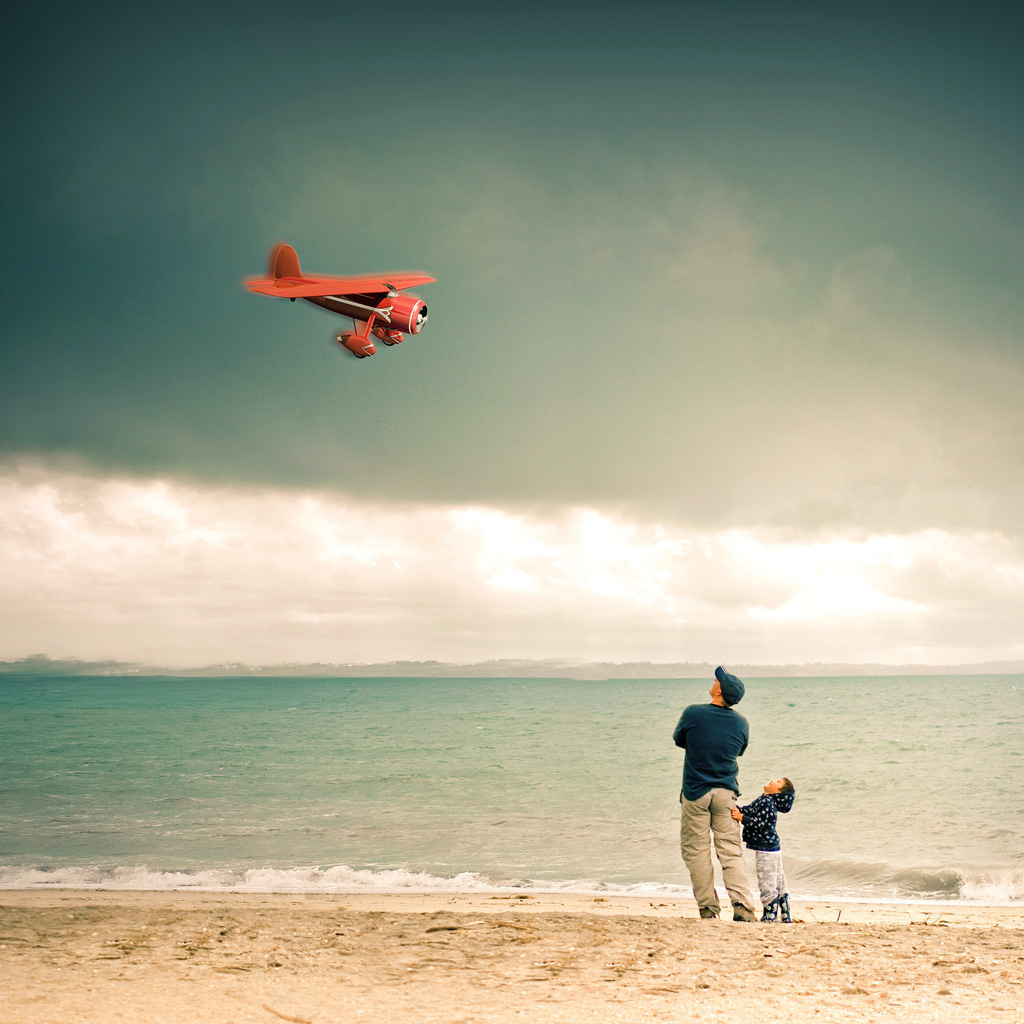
left=0, top=654, right=1024, bottom=680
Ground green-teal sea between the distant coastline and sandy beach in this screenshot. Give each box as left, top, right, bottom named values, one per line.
left=0, top=675, right=1024, bottom=905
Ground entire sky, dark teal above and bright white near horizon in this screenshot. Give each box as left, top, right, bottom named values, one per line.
left=0, top=0, right=1024, bottom=667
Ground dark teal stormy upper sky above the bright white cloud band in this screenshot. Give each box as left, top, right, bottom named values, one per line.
left=0, top=3, right=1024, bottom=536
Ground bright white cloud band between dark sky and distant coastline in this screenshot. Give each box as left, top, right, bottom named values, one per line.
left=0, top=465, right=1024, bottom=667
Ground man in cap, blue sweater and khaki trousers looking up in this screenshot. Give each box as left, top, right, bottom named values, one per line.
left=672, top=666, right=755, bottom=921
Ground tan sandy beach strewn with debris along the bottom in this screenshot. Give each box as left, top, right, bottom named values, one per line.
left=0, top=890, right=1024, bottom=1024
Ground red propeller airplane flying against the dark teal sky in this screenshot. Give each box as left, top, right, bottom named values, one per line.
left=246, top=242, right=437, bottom=359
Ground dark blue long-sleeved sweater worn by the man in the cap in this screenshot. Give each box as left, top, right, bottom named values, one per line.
left=672, top=705, right=750, bottom=800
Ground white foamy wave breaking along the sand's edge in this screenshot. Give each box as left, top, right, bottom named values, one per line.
left=0, top=861, right=1024, bottom=904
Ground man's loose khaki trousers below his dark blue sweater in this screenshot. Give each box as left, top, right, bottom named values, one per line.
left=679, top=790, right=754, bottom=913
